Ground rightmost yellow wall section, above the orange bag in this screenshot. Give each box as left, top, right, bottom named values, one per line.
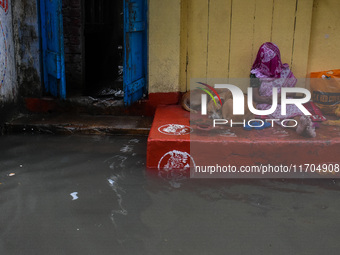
left=308, top=0, right=340, bottom=72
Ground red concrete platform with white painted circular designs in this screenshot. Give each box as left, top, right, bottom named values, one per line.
left=147, top=105, right=340, bottom=177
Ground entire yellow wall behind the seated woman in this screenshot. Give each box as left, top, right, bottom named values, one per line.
left=149, top=0, right=340, bottom=93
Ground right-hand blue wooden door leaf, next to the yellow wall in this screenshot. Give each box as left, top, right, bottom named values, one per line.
left=124, top=0, right=147, bottom=105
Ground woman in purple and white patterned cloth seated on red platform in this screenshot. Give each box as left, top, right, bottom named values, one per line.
left=250, top=42, right=316, bottom=137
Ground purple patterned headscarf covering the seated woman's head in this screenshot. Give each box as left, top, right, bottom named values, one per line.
left=250, top=42, right=288, bottom=78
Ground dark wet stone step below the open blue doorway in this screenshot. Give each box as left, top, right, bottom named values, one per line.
left=5, top=113, right=153, bottom=135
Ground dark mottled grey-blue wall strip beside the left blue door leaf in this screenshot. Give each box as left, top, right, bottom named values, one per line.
left=11, top=0, right=42, bottom=97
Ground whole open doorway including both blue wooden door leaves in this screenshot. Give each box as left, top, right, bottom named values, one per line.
left=40, top=0, right=147, bottom=105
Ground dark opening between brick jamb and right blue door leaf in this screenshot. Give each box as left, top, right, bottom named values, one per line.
left=84, top=0, right=124, bottom=98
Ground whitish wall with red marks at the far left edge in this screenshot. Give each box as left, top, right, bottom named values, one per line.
left=0, top=0, right=18, bottom=120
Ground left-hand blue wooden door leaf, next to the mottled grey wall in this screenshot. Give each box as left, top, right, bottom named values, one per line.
left=40, top=0, right=66, bottom=99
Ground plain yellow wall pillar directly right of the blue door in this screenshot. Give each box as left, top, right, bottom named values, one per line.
left=148, top=0, right=181, bottom=93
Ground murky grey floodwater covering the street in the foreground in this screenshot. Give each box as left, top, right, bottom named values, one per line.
left=0, top=135, right=340, bottom=255
